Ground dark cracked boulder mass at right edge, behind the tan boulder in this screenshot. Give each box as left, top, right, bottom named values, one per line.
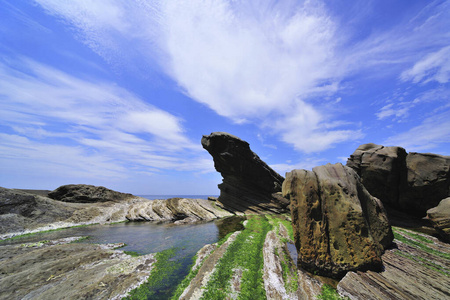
left=347, top=144, right=450, bottom=217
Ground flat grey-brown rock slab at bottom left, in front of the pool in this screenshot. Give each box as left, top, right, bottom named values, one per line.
left=0, top=238, right=155, bottom=300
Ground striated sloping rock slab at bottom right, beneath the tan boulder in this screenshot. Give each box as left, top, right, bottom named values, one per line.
left=337, top=230, right=450, bottom=300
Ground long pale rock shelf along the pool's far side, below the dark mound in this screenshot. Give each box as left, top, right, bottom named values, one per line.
left=0, top=186, right=225, bottom=239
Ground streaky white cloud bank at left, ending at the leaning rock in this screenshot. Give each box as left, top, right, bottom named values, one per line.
left=0, top=58, right=213, bottom=182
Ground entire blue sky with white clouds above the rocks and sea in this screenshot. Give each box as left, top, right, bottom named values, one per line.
left=0, top=0, right=450, bottom=194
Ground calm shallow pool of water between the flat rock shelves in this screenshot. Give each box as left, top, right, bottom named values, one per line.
left=0, top=217, right=245, bottom=299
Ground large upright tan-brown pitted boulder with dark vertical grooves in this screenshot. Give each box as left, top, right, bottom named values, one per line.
left=283, top=164, right=393, bottom=277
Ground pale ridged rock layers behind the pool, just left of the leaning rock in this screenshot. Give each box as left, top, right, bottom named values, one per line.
left=126, top=198, right=233, bottom=223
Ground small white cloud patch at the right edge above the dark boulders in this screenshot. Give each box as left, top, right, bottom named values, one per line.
left=401, top=46, right=450, bottom=83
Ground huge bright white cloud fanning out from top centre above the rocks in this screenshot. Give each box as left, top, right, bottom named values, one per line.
left=36, top=0, right=450, bottom=153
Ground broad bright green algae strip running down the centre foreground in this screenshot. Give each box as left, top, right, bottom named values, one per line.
left=202, top=216, right=271, bottom=299
